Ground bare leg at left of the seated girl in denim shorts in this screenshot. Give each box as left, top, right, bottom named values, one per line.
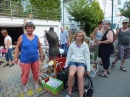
left=68, top=65, right=77, bottom=95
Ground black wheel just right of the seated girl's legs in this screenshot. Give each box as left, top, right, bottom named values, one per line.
left=83, top=76, right=94, bottom=97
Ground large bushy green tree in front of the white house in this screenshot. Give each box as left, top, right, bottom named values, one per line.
left=67, top=0, right=104, bottom=35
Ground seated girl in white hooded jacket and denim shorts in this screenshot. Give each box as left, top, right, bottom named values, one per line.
left=65, top=31, right=90, bottom=97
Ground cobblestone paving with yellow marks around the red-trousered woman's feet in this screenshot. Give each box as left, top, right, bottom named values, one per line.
left=0, top=63, right=45, bottom=97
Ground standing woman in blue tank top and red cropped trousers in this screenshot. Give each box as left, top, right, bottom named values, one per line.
left=14, top=22, right=44, bottom=92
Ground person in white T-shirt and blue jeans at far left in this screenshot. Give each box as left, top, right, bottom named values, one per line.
left=1, top=30, right=14, bottom=67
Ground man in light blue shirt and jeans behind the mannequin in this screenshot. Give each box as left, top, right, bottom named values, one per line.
left=60, top=27, right=70, bottom=53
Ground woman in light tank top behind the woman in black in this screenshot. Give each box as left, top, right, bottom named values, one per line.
left=92, top=21, right=104, bottom=64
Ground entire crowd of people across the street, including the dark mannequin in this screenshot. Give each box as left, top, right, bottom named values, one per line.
left=0, top=20, right=130, bottom=97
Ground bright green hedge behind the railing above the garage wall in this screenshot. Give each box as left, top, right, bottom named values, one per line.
left=30, top=0, right=61, bottom=20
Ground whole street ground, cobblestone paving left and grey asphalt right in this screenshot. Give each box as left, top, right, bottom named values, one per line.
left=0, top=58, right=130, bottom=97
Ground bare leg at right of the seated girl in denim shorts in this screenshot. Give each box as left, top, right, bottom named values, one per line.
left=77, top=66, right=85, bottom=97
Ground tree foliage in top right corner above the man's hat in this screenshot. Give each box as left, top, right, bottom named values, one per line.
left=119, top=1, right=130, bottom=20
